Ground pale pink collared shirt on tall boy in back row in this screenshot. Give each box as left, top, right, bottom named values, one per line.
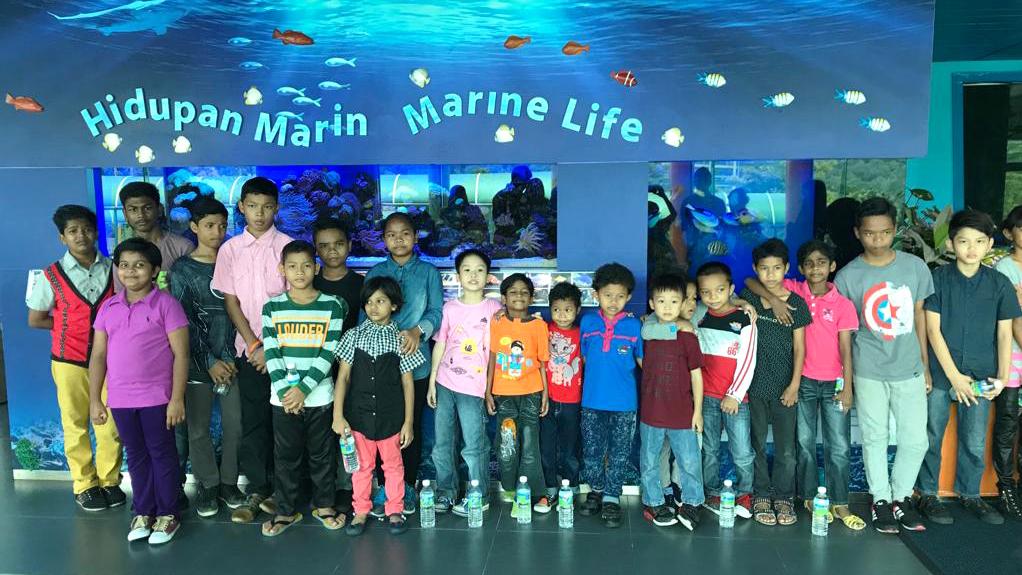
left=210, top=226, right=291, bottom=357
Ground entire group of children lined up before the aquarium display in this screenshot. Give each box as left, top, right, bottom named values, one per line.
left=27, top=183, right=1022, bottom=544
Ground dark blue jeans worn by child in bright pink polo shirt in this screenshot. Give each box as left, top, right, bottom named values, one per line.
left=796, top=377, right=851, bottom=506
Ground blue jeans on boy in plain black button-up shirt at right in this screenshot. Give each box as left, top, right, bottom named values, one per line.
left=916, top=387, right=990, bottom=498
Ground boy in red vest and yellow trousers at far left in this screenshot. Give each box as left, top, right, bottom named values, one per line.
left=25, top=204, right=126, bottom=511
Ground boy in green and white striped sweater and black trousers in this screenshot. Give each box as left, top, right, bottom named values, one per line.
left=263, top=240, right=347, bottom=537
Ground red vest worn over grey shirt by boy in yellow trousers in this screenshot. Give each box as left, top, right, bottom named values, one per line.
left=46, top=261, right=113, bottom=367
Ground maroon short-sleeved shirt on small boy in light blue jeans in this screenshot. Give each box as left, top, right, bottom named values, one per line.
left=639, top=332, right=702, bottom=429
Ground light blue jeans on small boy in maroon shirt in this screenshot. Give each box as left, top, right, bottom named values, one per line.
left=639, top=423, right=705, bottom=507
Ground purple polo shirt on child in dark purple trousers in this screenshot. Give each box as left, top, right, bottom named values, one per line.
left=94, top=289, right=188, bottom=408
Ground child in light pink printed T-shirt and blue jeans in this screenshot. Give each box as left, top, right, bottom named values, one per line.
left=426, top=249, right=501, bottom=516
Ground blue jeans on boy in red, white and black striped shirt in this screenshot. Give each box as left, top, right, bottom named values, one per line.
left=703, top=395, right=755, bottom=496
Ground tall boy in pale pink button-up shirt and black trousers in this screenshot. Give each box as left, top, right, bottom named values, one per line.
left=210, top=177, right=291, bottom=523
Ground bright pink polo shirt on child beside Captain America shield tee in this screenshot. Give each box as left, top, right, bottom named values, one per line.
left=784, top=280, right=858, bottom=381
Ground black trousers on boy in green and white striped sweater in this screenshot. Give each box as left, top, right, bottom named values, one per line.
left=273, top=404, right=339, bottom=515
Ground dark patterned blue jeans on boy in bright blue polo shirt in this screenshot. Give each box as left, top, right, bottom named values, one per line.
left=582, top=408, right=636, bottom=504
